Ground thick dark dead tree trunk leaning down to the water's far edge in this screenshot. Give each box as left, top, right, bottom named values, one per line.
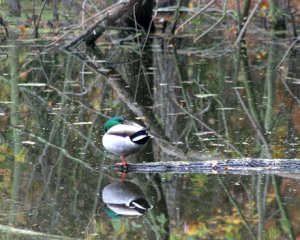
left=65, top=0, right=154, bottom=48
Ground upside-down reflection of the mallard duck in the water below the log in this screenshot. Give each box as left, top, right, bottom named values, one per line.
left=102, top=181, right=152, bottom=218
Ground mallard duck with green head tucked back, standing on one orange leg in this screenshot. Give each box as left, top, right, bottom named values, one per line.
left=102, top=117, right=151, bottom=167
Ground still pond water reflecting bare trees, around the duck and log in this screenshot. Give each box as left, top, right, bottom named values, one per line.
left=0, top=34, right=300, bottom=239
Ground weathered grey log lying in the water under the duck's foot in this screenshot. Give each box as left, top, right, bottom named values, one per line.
left=108, top=159, right=300, bottom=175
